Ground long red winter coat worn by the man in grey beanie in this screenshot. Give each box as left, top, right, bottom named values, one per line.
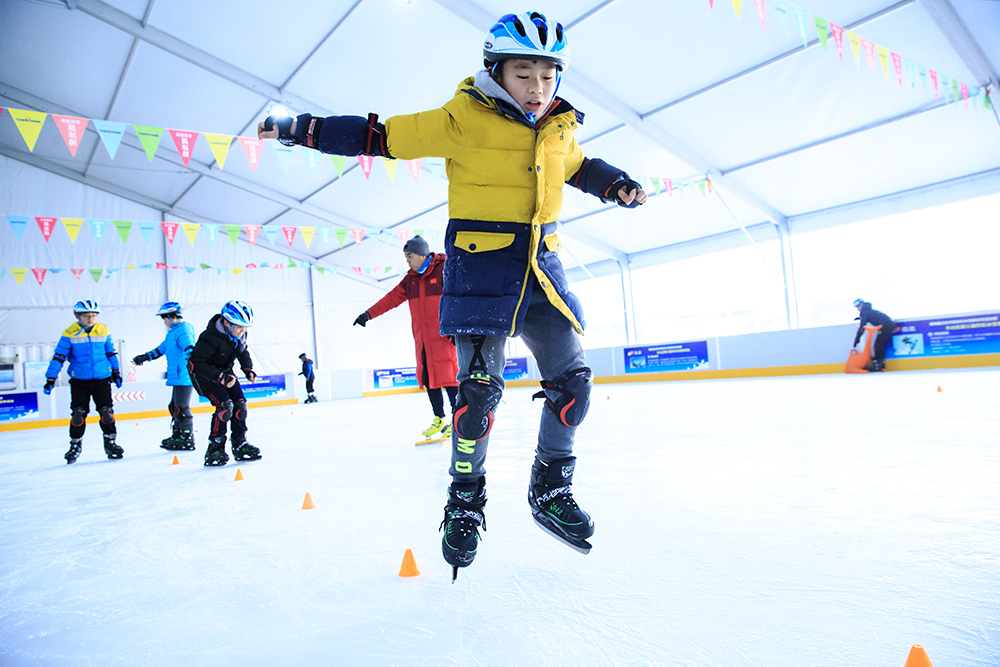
left=368, top=253, right=458, bottom=389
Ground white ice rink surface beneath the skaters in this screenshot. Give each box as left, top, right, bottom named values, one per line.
left=0, top=370, right=1000, bottom=667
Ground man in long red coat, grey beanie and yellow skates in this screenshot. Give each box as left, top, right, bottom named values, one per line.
left=354, top=236, right=458, bottom=439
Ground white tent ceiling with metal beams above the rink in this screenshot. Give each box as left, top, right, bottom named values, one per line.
left=0, top=0, right=1000, bottom=280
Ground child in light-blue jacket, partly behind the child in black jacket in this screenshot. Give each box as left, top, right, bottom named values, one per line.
left=132, top=301, right=195, bottom=451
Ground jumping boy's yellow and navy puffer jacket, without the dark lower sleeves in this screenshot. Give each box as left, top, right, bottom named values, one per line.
left=385, top=77, right=584, bottom=336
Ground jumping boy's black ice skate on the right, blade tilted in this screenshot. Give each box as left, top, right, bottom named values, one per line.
left=528, top=456, right=594, bottom=554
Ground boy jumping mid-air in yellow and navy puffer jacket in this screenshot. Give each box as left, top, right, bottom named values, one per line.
left=257, top=12, right=646, bottom=580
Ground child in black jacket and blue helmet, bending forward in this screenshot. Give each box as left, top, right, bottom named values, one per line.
left=188, top=301, right=261, bottom=466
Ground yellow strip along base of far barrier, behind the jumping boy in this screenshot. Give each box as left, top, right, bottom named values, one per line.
left=364, top=354, right=1000, bottom=398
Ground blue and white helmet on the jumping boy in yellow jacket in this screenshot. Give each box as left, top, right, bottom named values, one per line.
left=483, top=12, right=569, bottom=70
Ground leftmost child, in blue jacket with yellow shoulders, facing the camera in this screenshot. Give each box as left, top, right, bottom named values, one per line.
left=43, top=299, right=125, bottom=463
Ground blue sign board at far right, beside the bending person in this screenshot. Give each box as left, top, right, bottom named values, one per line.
left=885, top=313, right=1000, bottom=359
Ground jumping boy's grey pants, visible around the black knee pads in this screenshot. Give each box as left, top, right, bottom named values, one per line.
left=448, top=285, right=587, bottom=483
